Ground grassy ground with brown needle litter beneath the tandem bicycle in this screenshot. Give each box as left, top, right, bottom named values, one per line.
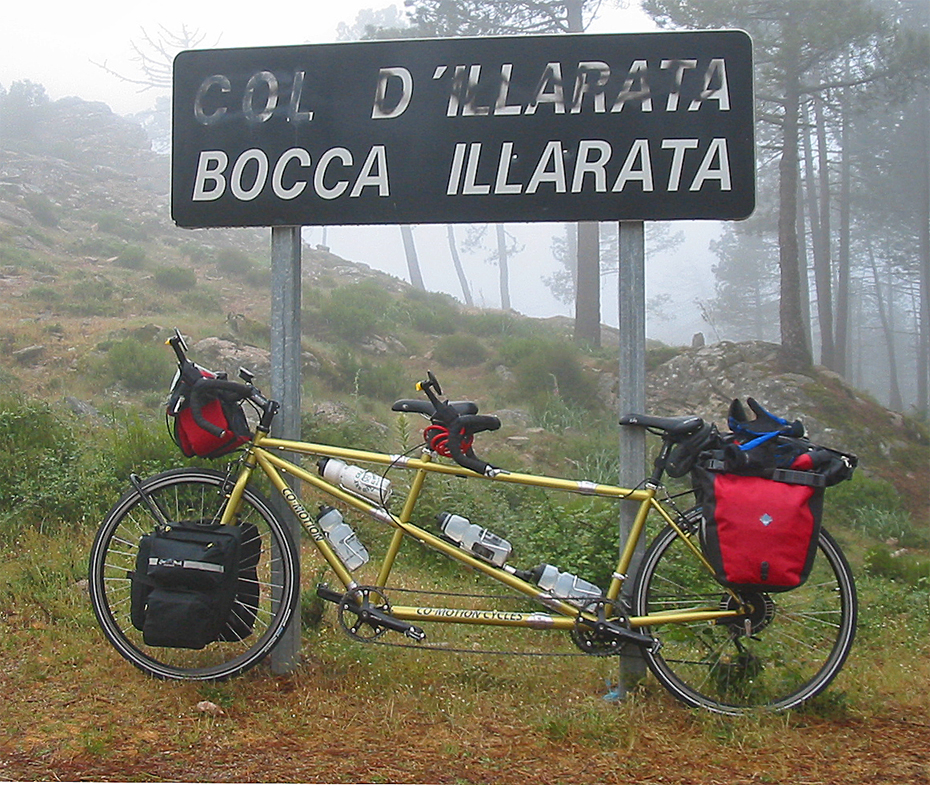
left=0, top=512, right=930, bottom=785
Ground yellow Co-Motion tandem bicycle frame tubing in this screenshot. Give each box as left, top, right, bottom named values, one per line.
left=212, top=430, right=745, bottom=630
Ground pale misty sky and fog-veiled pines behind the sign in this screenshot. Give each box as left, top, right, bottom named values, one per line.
left=0, top=0, right=930, bottom=415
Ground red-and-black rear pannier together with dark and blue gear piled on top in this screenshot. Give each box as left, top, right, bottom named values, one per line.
left=692, top=398, right=857, bottom=592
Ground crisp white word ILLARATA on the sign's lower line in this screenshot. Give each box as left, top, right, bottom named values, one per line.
left=446, top=138, right=732, bottom=196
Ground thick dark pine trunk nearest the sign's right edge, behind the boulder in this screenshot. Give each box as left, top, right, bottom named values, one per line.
left=778, top=71, right=811, bottom=369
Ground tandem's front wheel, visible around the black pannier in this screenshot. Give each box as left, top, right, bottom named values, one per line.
left=88, top=469, right=300, bottom=681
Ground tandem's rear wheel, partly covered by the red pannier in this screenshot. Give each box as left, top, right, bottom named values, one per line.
left=632, top=526, right=857, bottom=715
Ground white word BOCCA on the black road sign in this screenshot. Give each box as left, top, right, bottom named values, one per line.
left=192, top=145, right=391, bottom=202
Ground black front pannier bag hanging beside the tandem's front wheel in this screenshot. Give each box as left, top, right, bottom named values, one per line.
left=130, top=521, right=246, bottom=649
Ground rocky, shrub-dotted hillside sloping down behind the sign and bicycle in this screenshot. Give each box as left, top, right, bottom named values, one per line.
left=0, top=98, right=928, bottom=499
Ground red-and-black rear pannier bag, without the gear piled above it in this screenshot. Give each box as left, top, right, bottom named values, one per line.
left=693, top=465, right=824, bottom=592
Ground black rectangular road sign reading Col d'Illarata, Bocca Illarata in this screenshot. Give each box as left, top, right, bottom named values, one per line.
left=171, top=30, right=755, bottom=227
